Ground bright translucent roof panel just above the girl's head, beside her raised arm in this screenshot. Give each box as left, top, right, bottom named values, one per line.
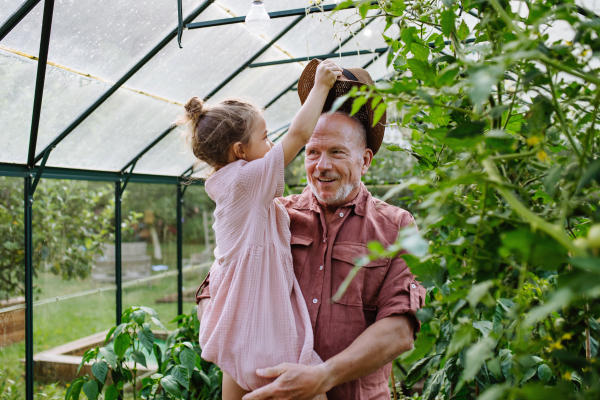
left=209, top=48, right=303, bottom=106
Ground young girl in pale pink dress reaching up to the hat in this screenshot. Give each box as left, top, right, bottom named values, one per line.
left=180, top=61, right=342, bottom=400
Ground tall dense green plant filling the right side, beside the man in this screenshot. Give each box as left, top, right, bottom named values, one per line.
left=334, top=0, right=600, bottom=400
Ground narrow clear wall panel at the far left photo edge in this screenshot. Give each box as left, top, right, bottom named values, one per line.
left=0, top=176, right=25, bottom=399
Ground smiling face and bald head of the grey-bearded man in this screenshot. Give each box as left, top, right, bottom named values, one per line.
left=304, top=113, right=373, bottom=207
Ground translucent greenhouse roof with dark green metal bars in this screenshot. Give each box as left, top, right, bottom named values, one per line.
left=0, top=0, right=598, bottom=183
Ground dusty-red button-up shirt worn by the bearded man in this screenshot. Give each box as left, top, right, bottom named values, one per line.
left=197, top=184, right=425, bottom=400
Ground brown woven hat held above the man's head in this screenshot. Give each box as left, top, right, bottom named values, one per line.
left=298, top=58, right=385, bottom=154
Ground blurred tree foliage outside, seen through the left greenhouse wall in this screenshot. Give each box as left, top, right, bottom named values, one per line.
left=0, top=177, right=140, bottom=297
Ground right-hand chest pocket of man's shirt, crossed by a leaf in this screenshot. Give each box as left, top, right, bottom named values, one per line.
left=331, top=243, right=389, bottom=310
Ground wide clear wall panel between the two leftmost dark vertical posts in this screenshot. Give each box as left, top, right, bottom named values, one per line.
left=33, top=179, right=116, bottom=397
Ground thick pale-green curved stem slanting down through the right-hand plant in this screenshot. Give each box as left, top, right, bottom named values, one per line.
left=479, top=144, right=586, bottom=257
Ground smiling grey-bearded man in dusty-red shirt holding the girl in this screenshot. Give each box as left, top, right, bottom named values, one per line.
left=198, top=61, right=425, bottom=400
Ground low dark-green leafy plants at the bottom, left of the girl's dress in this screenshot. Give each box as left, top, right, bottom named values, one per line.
left=65, top=306, right=223, bottom=400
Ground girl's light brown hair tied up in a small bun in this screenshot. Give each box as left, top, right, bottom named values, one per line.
left=177, top=97, right=262, bottom=170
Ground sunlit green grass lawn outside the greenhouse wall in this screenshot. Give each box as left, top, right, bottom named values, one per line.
left=0, top=245, right=203, bottom=399
